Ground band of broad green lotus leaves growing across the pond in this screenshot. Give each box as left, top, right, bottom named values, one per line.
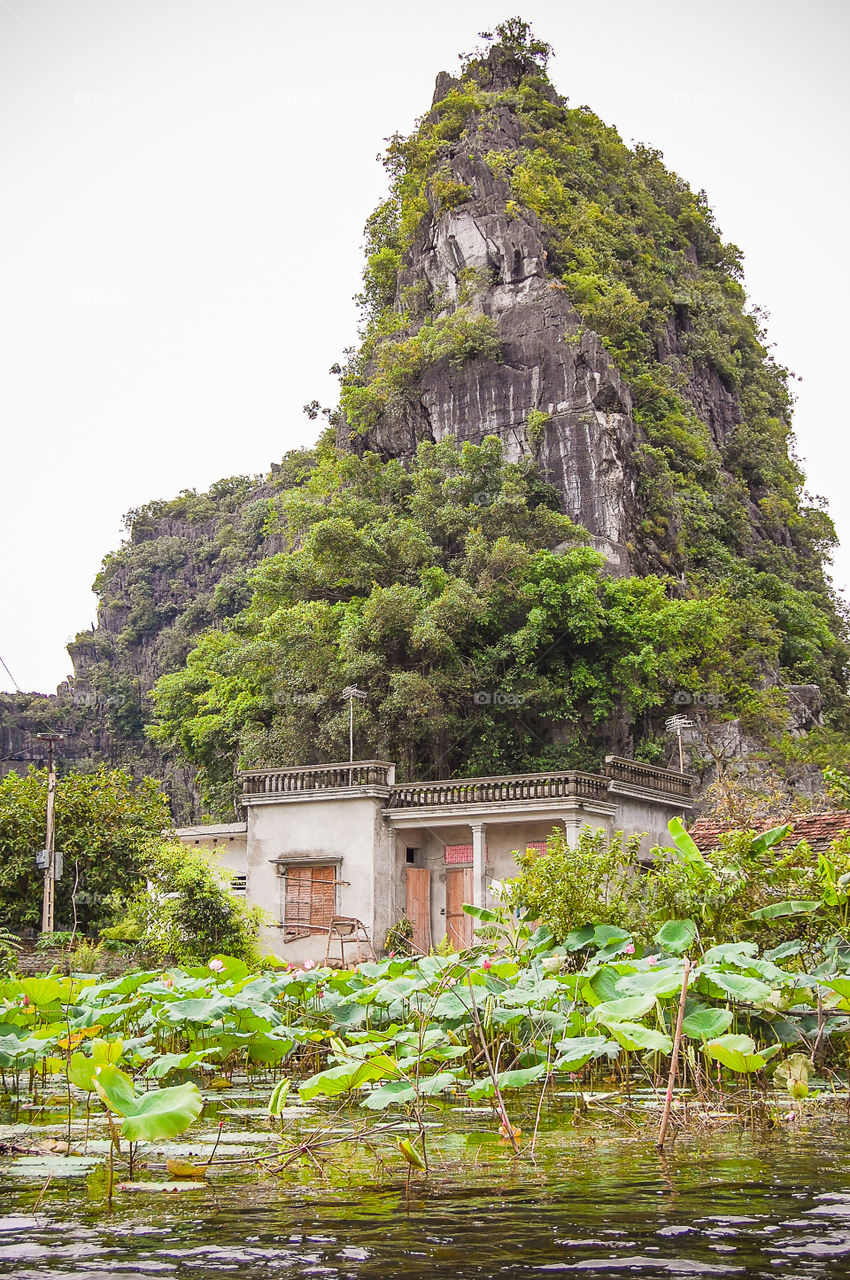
left=0, top=909, right=850, bottom=1139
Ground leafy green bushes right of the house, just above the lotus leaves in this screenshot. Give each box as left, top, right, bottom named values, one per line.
left=507, top=815, right=850, bottom=964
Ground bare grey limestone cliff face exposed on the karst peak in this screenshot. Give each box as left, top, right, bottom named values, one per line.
left=341, top=90, right=639, bottom=572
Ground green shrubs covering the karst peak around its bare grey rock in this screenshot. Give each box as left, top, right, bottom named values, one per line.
left=342, top=19, right=847, bottom=710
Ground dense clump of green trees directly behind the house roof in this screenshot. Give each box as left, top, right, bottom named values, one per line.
left=145, top=438, right=818, bottom=810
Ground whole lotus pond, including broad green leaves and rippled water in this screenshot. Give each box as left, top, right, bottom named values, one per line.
left=0, top=922, right=850, bottom=1276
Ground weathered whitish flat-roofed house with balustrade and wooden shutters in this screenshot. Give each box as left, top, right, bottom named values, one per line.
left=171, top=756, right=693, bottom=961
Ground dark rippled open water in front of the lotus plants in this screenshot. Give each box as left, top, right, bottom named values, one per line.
left=0, top=1112, right=850, bottom=1280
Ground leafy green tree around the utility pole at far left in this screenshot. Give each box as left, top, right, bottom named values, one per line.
left=0, top=769, right=169, bottom=932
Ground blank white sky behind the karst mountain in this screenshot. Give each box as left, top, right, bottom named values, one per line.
left=0, top=0, right=850, bottom=691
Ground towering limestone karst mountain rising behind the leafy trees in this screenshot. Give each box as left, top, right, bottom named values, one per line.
left=0, top=19, right=847, bottom=815
